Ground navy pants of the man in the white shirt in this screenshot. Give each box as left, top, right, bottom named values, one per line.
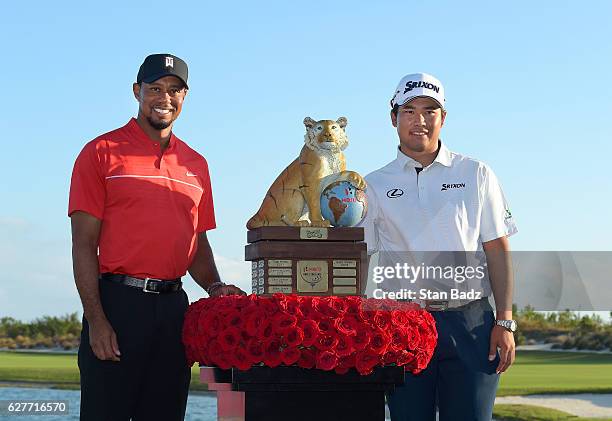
left=387, top=299, right=499, bottom=421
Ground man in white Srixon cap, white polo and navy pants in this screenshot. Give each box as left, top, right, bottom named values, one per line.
left=361, top=73, right=517, bottom=421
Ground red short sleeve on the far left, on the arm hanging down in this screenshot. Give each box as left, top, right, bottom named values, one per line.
left=68, top=141, right=106, bottom=220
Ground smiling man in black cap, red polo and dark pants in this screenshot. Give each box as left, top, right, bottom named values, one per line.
left=68, top=54, right=243, bottom=421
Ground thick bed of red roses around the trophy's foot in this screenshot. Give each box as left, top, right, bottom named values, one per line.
left=183, top=294, right=438, bottom=375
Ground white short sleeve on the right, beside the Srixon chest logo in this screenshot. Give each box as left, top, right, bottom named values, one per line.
left=480, top=165, right=518, bottom=243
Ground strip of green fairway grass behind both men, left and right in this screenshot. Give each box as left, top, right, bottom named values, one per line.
left=0, top=351, right=612, bottom=396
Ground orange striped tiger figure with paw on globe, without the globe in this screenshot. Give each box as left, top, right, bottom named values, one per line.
left=247, top=117, right=366, bottom=229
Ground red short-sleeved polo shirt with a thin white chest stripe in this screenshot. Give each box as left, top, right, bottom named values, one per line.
left=68, top=119, right=215, bottom=279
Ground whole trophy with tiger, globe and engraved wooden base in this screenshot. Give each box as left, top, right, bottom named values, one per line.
left=245, top=117, right=367, bottom=295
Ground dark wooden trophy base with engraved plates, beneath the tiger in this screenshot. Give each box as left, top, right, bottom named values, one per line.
left=245, top=227, right=368, bottom=296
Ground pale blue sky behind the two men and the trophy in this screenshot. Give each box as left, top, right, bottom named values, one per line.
left=0, top=1, right=612, bottom=319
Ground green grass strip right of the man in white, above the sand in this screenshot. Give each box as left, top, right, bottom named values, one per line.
left=497, top=351, right=612, bottom=396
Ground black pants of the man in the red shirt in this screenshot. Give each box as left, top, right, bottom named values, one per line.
left=78, top=281, right=191, bottom=421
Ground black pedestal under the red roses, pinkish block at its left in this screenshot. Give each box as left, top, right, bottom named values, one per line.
left=200, top=367, right=404, bottom=421
